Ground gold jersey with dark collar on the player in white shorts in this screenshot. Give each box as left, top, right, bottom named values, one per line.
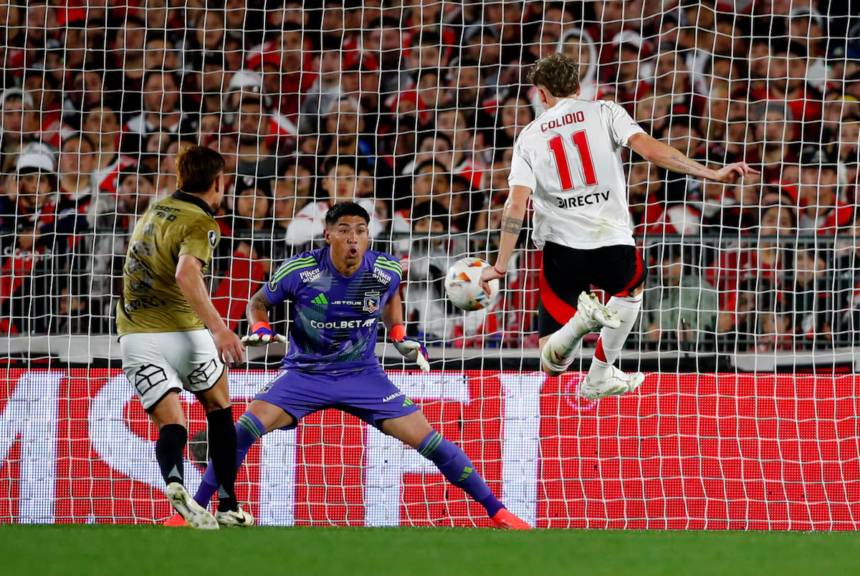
left=116, top=191, right=221, bottom=336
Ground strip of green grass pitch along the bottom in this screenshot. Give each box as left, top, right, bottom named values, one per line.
left=0, top=525, right=860, bottom=576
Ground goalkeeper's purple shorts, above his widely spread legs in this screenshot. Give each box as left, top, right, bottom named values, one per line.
left=254, top=366, right=420, bottom=429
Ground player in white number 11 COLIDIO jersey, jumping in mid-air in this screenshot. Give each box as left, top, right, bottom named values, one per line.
left=482, top=54, right=758, bottom=399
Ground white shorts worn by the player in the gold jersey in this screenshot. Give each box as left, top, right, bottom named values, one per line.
left=119, top=330, right=224, bottom=412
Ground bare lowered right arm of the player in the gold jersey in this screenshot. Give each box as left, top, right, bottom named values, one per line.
left=175, top=254, right=245, bottom=366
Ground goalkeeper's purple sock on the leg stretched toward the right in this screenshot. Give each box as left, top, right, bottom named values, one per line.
left=418, top=430, right=504, bottom=518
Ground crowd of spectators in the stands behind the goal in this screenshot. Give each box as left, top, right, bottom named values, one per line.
left=0, top=0, right=860, bottom=351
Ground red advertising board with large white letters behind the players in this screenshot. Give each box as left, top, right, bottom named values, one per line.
left=0, top=369, right=860, bottom=530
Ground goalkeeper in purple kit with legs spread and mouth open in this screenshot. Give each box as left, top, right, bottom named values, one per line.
left=175, top=202, right=530, bottom=530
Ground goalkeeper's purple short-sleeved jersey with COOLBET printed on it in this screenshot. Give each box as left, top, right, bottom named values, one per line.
left=264, top=247, right=402, bottom=373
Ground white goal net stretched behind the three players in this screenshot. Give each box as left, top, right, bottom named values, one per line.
left=5, top=0, right=860, bottom=530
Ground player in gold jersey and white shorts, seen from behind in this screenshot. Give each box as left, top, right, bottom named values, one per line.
left=116, top=146, right=254, bottom=530
